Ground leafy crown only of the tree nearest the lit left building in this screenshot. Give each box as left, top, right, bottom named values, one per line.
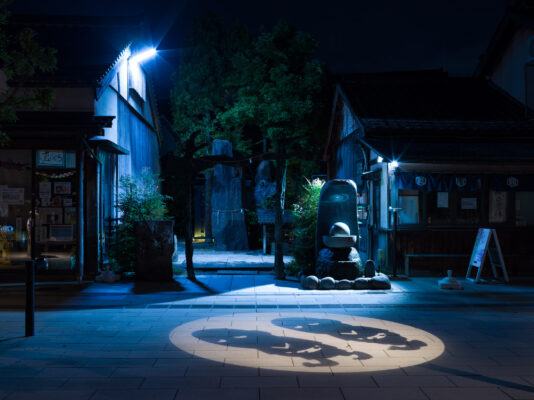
left=171, top=13, right=252, bottom=155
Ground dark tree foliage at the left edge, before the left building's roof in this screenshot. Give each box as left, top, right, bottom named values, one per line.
left=0, top=0, right=56, bottom=146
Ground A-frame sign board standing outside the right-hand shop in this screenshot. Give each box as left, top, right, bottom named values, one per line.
left=466, top=228, right=510, bottom=283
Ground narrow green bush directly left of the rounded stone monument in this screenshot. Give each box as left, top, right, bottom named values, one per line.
left=286, top=179, right=324, bottom=275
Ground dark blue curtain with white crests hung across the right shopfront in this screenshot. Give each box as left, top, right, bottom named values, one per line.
left=395, top=172, right=534, bottom=192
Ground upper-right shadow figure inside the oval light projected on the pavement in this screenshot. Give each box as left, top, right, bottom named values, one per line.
left=271, top=318, right=427, bottom=351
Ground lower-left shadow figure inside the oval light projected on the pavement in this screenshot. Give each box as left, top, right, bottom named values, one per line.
left=192, top=328, right=371, bottom=367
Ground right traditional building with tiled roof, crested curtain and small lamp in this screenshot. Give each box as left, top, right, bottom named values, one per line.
left=324, top=70, right=534, bottom=275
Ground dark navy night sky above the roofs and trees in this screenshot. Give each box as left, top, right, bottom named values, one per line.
left=12, top=0, right=511, bottom=98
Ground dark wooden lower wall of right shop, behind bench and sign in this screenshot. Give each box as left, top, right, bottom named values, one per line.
left=397, top=227, right=534, bottom=276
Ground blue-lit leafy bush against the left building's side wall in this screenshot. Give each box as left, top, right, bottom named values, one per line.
left=110, top=169, right=169, bottom=271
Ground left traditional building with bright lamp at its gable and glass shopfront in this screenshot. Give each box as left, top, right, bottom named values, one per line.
left=0, top=16, right=159, bottom=279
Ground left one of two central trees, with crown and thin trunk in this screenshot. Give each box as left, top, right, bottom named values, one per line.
left=171, top=13, right=252, bottom=280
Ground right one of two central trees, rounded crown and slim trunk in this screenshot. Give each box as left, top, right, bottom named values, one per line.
left=221, top=21, right=323, bottom=279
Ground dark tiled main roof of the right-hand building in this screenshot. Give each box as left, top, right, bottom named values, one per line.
left=340, top=71, right=524, bottom=124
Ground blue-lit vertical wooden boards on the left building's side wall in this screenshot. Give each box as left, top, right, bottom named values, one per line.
left=117, top=100, right=160, bottom=176
